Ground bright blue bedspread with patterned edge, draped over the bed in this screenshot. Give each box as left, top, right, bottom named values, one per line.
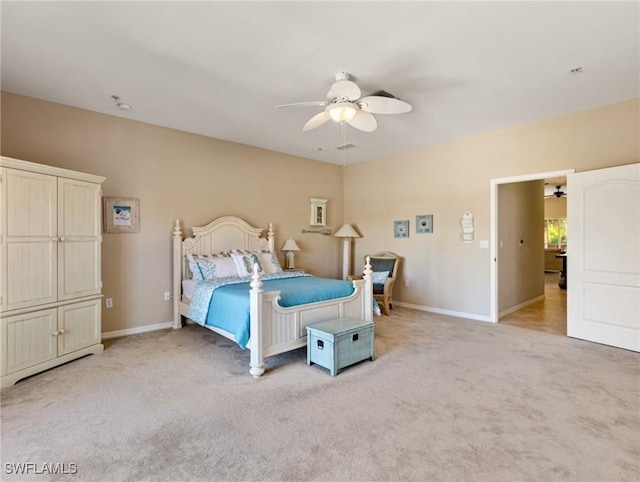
left=188, top=273, right=354, bottom=349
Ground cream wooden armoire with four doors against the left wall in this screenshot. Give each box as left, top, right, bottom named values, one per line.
left=0, top=157, right=105, bottom=387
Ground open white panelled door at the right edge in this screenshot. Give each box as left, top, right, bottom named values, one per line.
left=567, top=164, right=640, bottom=351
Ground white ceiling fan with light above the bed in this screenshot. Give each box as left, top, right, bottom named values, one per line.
left=276, top=72, right=412, bottom=132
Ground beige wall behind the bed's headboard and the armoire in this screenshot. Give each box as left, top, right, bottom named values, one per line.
left=1, top=93, right=343, bottom=332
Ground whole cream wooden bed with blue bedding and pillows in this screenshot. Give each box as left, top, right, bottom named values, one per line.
left=172, top=216, right=373, bottom=378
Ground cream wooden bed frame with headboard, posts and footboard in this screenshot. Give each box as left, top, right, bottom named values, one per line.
left=173, top=216, right=373, bottom=378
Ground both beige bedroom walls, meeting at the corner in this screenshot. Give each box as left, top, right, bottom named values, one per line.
left=2, top=94, right=640, bottom=331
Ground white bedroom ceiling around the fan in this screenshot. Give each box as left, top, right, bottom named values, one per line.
left=1, top=1, right=640, bottom=164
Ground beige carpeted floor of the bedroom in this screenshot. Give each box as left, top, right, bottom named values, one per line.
left=1, top=308, right=640, bottom=482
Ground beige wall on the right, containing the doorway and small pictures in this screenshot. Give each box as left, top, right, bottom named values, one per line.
left=344, top=99, right=640, bottom=318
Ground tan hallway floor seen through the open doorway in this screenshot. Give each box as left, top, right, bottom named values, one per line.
left=500, top=273, right=567, bottom=336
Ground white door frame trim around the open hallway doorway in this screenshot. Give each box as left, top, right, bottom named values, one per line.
left=490, top=169, right=574, bottom=323
